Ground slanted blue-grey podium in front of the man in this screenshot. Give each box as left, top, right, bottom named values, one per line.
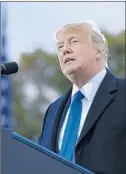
left=1, top=128, right=93, bottom=174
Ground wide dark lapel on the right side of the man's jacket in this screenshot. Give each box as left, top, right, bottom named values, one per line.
left=78, top=70, right=117, bottom=147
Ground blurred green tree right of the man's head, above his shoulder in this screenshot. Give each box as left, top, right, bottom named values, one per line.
left=104, top=31, right=126, bottom=77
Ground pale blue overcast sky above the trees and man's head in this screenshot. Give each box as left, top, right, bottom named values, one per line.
left=0, top=2, right=125, bottom=61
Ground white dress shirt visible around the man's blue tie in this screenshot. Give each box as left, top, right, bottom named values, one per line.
left=58, top=68, right=106, bottom=150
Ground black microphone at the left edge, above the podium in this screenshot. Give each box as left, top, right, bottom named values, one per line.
left=1, top=62, right=18, bottom=75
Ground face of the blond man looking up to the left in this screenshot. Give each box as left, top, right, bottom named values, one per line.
left=57, top=28, right=97, bottom=77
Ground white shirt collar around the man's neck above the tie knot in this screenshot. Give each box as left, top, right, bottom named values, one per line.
left=72, top=68, right=106, bottom=102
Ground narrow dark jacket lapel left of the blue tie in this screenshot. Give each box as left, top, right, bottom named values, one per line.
left=51, top=88, right=72, bottom=152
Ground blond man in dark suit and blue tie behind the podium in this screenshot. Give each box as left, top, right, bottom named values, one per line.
left=39, top=21, right=126, bottom=174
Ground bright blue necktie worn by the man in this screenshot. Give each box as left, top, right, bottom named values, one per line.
left=59, top=91, right=84, bottom=160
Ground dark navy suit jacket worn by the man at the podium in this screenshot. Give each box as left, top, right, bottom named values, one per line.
left=38, top=70, right=126, bottom=174
